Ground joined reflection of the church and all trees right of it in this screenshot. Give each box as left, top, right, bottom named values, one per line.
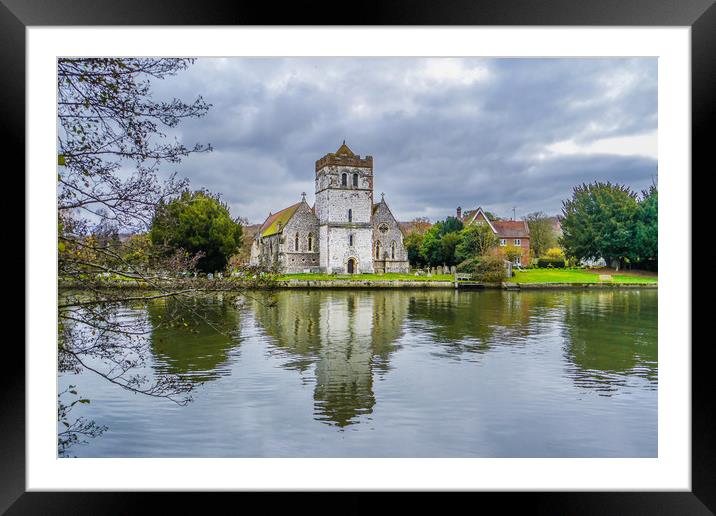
left=251, top=289, right=656, bottom=427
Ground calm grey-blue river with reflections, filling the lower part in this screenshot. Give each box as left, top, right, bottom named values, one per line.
left=58, top=289, right=658, bottom=457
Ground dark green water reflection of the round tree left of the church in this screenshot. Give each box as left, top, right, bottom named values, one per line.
left=147, top=294, right=239, bottom=383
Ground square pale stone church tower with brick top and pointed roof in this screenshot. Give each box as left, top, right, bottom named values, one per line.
left=315, top=140, right=373, bottom=274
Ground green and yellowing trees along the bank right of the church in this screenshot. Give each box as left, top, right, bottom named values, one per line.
left=404, top=181, right=658, bottom=270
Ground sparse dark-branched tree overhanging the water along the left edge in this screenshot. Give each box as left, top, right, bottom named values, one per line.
left=57, top=58, right=272, bottom=454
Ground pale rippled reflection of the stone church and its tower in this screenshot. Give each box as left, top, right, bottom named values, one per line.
left=253, top=291, right=407, bottom=427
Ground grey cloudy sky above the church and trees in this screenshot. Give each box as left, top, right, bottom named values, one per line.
left=153, top=58, right=657, bottom=223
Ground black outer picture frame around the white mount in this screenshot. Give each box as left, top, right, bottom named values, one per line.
left=5, top=0, right=716, bottom=515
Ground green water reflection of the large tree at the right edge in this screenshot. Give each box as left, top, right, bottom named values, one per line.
left=563, top=290, right=658, bottom=395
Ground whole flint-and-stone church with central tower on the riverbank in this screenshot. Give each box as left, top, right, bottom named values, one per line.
left=251, top=141, right=408, bottom=274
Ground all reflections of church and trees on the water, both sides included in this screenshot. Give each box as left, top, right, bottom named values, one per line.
left=154, top=289, right=658, bottom=427
